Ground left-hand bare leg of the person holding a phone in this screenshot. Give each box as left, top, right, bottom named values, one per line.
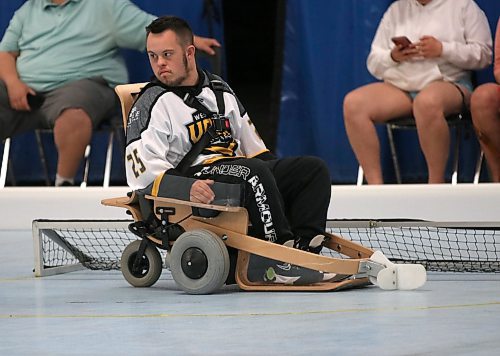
left=344, top=83, right=412, bottom=184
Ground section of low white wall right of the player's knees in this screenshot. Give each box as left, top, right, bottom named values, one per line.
left=328, top=183, right=500, bottom=222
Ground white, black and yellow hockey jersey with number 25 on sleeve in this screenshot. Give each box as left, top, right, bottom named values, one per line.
left=125, top=71, right=268, bottom=190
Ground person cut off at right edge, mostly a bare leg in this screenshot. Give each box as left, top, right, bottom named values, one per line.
left=471, top=18, right=500, bottom=183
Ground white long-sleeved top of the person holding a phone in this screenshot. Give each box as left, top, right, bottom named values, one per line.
left=367, top=0, right=492, bottom=91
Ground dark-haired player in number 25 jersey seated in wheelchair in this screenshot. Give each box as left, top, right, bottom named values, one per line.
left=125, top=17, right=331, bottom=284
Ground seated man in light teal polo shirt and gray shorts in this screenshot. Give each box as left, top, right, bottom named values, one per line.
left=0, top=0, right=220, bottom=186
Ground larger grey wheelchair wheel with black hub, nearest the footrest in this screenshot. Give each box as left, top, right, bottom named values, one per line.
left=170, top=229, right=230, bottom=294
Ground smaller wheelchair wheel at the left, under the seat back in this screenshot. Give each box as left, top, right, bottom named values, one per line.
left=121, top=240, right=162, bottom=287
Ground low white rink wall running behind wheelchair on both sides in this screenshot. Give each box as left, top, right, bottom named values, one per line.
left=0, top=183, right=500, bottom=230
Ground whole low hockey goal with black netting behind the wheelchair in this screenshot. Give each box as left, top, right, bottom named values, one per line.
left=33, top=220, right=500, bottom=276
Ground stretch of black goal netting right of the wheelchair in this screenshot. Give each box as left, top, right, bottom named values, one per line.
left=328, top=223, right=500, bottom=272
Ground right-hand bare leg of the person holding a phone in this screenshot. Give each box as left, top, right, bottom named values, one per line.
left=413, top=82, right=470, bottom=183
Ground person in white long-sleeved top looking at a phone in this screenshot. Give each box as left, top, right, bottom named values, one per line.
left=344, top=0, right=492, bottom=184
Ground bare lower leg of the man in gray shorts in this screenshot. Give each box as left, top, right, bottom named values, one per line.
left=54, top=109, right=92, bottom=178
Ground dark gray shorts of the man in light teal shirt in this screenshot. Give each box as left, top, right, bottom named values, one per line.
left=0, top=77, right=118, bottom=139
